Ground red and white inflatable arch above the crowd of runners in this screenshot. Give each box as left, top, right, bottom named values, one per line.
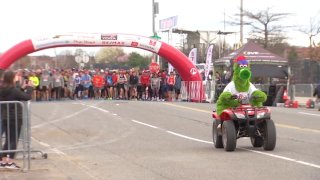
left=0, top=33, right=202, bottom=81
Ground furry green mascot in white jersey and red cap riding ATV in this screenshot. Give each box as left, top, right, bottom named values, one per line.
left=217, top=56, right=267, bottom=115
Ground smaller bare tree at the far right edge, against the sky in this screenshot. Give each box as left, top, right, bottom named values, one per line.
left=299, top=16, right=320, bottom=59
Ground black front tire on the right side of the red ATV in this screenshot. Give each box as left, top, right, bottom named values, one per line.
left=263, top=119, right=277, bottom=151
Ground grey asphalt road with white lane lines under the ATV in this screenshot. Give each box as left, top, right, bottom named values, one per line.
left=0, top=100, right=320, bottom=180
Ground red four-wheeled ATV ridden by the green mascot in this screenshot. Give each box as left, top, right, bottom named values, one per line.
left=212, top=96, right=276, bottom=151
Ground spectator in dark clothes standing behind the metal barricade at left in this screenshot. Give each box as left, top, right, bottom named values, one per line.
left=0, top=71, right=32, bottom=169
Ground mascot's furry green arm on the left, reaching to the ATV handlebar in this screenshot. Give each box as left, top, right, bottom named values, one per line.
left=217, top=92, right=239, bottom=115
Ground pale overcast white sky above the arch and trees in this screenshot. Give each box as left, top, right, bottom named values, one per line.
left=0, top=0, right=320, bottom=55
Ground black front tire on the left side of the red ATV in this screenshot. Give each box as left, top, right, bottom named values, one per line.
left=222, top=121, right=237, bottom=151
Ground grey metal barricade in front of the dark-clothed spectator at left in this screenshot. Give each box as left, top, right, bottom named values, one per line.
left=0, top=101, right=31, bottom=171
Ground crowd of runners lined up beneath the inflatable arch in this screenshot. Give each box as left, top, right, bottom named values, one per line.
left=15, top=68, right=182, bottom=101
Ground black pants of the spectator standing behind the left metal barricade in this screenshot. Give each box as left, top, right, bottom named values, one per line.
left=0, top=116, right=22, bottom=159
